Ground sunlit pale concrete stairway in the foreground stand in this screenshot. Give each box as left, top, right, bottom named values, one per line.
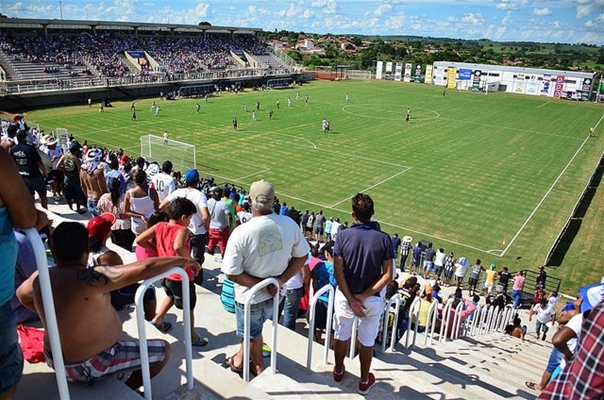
left=15, top=198, right=551, bottom=400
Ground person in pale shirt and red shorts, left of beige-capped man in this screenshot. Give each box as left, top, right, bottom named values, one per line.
left=208, top=186, right=233, bottom=262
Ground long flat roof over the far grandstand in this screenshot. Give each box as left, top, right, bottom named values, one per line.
left=0, top=18, right=262, bottom=34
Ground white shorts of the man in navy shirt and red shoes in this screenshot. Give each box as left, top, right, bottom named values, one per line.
left=334, top=289, right=384, bottom=347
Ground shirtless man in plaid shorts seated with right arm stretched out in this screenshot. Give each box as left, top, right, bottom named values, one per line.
left=17, top=222, right=199, bottom=389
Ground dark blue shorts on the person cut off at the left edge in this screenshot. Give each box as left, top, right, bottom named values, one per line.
left=0, top=301, right=23, bottom=394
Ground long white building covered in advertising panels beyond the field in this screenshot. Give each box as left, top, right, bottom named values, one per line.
left=426, top=61, right=596, bottom=100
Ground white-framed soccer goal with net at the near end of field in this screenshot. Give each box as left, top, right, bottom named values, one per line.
left=141, top=135, right=197, bottom=173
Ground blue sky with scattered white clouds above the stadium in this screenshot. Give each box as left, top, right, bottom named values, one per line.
left=0, top=0, right=604, bottom=46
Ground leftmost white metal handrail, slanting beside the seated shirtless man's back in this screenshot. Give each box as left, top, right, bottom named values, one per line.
left=24, top=228, right=69, bottom=400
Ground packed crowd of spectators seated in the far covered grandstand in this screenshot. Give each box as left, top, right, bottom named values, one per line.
left=0, top=30, right=278, bottom=83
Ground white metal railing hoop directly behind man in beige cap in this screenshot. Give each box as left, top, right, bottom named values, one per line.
left=243, top=278, right=279, bottom=382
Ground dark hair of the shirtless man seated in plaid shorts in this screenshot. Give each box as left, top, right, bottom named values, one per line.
left=52, top=222, right=88, bottom=266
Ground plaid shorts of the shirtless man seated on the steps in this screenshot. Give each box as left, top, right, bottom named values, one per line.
left=44, top=339, right=166, bottom=384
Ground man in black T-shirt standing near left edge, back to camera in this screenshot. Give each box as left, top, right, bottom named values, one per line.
left=10, top=130, right=48, bottom=209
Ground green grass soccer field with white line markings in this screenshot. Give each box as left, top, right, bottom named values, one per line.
left=27, top=80, right=604, bottom=292
